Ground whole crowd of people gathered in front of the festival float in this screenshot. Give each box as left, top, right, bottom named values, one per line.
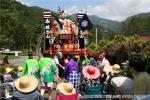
left=0, top=49, right=150, bottom=100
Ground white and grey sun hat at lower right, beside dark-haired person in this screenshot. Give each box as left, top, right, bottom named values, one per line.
left=111, top=76, right=133, bottom=95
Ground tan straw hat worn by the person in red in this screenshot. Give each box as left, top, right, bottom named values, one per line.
left=57, top=83, right=76, bottom=95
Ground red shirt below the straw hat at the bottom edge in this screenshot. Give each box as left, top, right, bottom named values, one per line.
left=56, top=93, right=79, bottom=100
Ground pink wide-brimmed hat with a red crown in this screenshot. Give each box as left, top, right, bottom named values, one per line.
left=82, top=66, right=100, bottom=79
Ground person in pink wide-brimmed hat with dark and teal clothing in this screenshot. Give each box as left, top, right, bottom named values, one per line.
left=80, top=66, right=102, bottom=100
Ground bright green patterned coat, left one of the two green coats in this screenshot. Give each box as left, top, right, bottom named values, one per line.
left=22, top=59, right=39, bottom=78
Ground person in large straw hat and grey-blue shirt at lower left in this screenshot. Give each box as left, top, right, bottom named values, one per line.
left=12, top=75, right=44, bottom=100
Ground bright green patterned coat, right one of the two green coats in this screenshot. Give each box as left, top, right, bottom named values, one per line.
left=39, top=57, right=58, bottom=83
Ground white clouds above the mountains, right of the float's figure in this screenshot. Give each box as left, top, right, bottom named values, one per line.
left=66, top=0, right=150, bottom=21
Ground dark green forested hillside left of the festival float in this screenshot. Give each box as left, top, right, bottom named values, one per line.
left=0, top=0, right=44, bottom=49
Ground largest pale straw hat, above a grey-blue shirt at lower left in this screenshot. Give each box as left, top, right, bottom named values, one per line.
left=15, top=75, right=38, bottom=93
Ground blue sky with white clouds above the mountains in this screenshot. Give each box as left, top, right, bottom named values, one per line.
left=16, top=0, right=150, bottom=21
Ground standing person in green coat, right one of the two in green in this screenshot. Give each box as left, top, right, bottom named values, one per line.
left=39, top=51, right=58, bottom=99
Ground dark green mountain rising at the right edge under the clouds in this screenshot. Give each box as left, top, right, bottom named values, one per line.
left=122, top=12, right=150, bottom=35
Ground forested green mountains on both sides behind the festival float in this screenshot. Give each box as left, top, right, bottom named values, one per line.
left=0, top=0, right=150, bottom=50
